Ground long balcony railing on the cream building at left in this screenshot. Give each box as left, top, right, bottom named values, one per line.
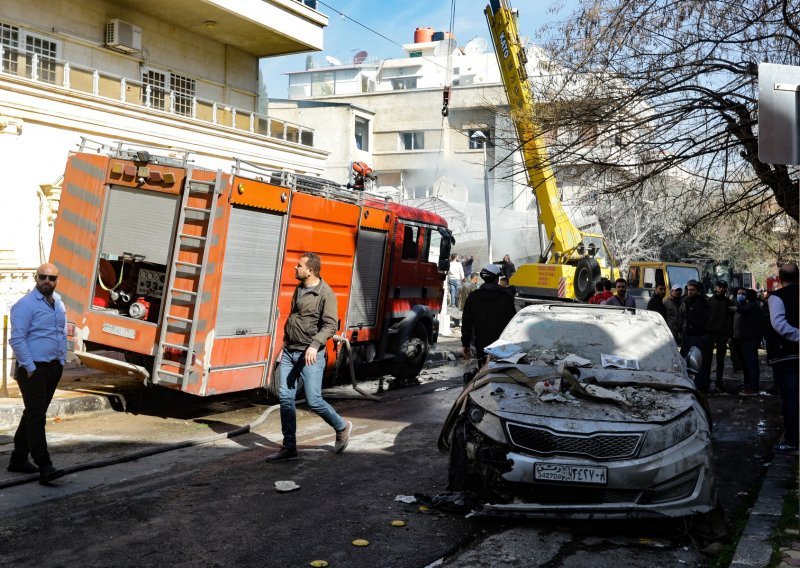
left=0, top=45, right=314, bottom=146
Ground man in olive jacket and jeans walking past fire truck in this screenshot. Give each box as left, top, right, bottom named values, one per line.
left=266, top=252, right=353, bottom=462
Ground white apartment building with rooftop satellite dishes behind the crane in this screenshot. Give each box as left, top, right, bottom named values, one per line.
left=270, top=29, right=564, bottom=261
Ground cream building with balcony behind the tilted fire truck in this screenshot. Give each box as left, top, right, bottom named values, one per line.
left=0, top=0, right=328, bottom=320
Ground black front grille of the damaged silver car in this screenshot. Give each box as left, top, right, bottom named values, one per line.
left=507, top=423, right=642, bottom=460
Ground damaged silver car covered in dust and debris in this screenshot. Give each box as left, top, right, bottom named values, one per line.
left=439, top=303, right=717, bottom=518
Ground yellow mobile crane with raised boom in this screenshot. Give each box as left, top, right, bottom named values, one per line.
left=484, top=0, right=620, bottom=301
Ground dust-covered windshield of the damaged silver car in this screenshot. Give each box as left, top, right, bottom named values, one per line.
left=491, top=304, right=682, bottom=372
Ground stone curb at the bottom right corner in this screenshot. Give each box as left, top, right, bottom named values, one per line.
left=730, top=454, right=797, bottom=568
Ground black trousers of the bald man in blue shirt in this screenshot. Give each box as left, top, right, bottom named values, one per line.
left=11, top=361, right=64, bottom=468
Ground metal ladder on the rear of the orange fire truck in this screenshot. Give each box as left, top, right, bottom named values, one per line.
left=153, top=166, right=222, bottom=389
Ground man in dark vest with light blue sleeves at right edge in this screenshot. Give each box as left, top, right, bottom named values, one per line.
left=766, top=262, right=800, bottom=455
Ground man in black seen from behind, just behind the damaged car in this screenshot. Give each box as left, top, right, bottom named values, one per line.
left=461, top=264, right=517, bottom=366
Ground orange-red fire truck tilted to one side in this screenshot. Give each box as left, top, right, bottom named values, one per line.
left=50, top=146, right=455, bottom=396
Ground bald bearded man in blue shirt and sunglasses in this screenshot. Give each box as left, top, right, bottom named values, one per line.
left=8, top=263, right=67, bottom=484
